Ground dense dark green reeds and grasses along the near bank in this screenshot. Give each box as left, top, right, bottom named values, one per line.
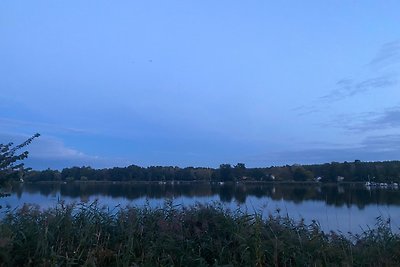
left=0, top=202, right=400, bottom=266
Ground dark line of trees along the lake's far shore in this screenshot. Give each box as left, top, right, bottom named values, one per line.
left=24, top=160, right=400, bottom=182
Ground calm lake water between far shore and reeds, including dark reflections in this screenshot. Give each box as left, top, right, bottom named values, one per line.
left=0, top=183, right=400, bottom=236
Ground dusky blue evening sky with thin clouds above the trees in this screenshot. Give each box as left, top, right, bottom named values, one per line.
left=0, top=0, right=400, bottom=169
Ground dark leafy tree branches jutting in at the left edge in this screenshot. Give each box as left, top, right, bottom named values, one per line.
left=0, top=133, right=40, bottom=186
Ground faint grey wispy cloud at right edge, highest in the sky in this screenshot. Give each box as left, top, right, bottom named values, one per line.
left=369, top=41, right=400, bottom=67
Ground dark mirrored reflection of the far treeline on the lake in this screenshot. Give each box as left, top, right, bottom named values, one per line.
left=9, top=183, right=400, bottom=209
